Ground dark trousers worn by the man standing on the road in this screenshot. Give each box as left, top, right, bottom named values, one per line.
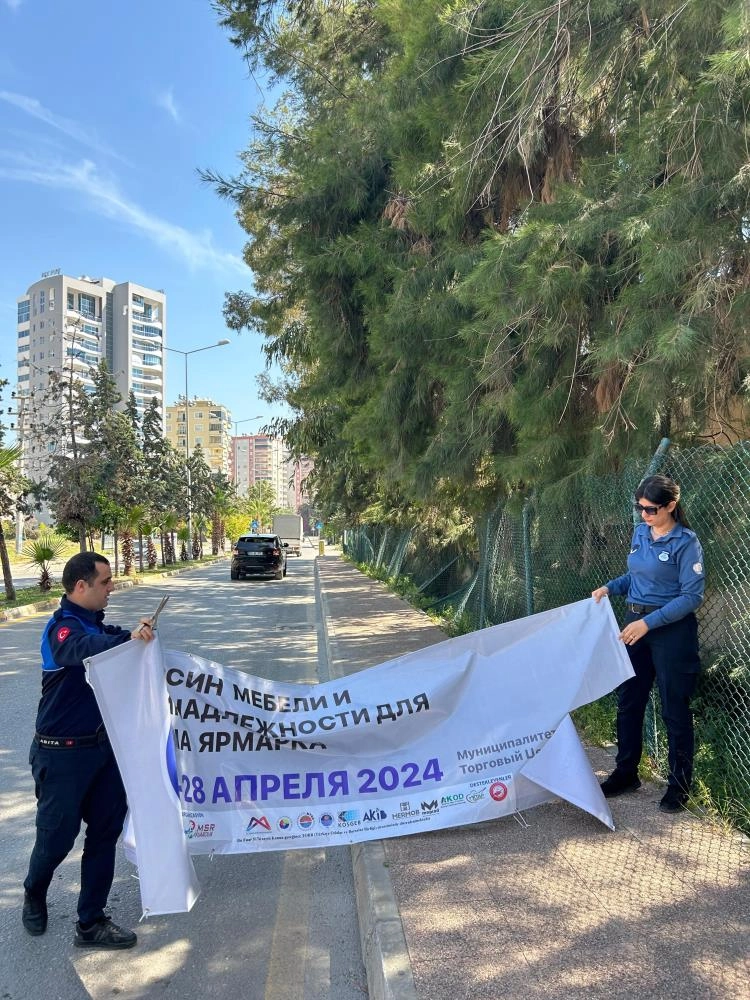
left=24, top=740, right=127, bottom=924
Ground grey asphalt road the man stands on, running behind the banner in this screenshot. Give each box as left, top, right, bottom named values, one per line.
left=0, top=548, right=367, bottom=1000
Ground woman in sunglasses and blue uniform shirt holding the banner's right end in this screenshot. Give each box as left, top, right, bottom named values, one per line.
left=591, top=476, right=705, bottom=812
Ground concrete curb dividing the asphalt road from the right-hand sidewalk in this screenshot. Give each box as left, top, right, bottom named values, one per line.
left=315, top=556, right=417, bottom=1000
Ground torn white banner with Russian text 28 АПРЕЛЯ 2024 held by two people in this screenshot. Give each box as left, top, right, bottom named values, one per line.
left=88, top=599, right=632, bottom=913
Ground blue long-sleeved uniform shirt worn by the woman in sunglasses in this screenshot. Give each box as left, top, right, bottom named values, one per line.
left=606, top=524, right=705, bottom=628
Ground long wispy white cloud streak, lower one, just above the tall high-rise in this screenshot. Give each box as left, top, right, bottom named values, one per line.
left=0, top=154, right=248, bottom=277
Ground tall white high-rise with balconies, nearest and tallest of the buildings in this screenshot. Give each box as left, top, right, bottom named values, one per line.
left=16, top=271, right=167, bottom=482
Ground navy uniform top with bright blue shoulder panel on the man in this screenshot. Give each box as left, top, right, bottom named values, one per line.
left=36, top=597, right=130, bottom=736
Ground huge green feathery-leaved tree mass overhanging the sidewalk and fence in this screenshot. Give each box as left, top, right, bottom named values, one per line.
left=210, top=0, right=750, bottom=523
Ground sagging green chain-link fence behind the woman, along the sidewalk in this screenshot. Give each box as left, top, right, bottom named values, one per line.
left=344, top=442, right=750, bottom=832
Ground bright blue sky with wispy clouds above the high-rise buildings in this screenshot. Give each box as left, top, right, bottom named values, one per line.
left=0, top=0, right=280, bottom=433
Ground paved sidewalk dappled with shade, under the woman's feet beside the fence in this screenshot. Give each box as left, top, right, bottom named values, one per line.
left=317, top=555, right=750, bottom=1000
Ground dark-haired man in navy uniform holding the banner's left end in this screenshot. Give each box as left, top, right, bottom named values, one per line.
left=23, top=552, right=153, bottom=948
